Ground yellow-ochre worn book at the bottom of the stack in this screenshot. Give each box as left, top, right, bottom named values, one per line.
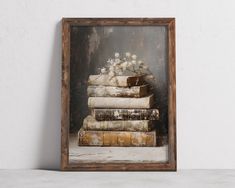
left=78, top=129, right=157, bottom=147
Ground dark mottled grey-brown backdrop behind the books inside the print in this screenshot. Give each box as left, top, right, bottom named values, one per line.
left=70, top=26, right=168, bottom=134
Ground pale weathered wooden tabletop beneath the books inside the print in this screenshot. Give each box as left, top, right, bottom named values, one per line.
left=69, top=135, right=168, bottom=163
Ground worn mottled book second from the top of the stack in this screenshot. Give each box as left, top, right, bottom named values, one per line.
left=87, top=85, right=148, bottom=97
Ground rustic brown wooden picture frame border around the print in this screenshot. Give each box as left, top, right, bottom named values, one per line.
left=61, top=18, right=177, bottom=171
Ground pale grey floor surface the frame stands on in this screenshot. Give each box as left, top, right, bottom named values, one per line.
left=0, top=170, right=235, bottom=188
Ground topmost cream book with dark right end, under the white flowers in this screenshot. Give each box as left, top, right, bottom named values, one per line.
left=88, top=74, right=144, bottom=87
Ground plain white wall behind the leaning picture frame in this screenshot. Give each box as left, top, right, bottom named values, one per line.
left=0, top=0, right=235, bottom=169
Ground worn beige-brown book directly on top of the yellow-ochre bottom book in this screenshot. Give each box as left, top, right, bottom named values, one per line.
left=83, top=115, right=153, bottom=131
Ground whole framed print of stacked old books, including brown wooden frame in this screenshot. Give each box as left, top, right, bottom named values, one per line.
left=61, top=18, right=176, bottom=171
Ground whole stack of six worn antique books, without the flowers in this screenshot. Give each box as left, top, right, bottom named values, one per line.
left=78, top=75, right=159, bottom=147
